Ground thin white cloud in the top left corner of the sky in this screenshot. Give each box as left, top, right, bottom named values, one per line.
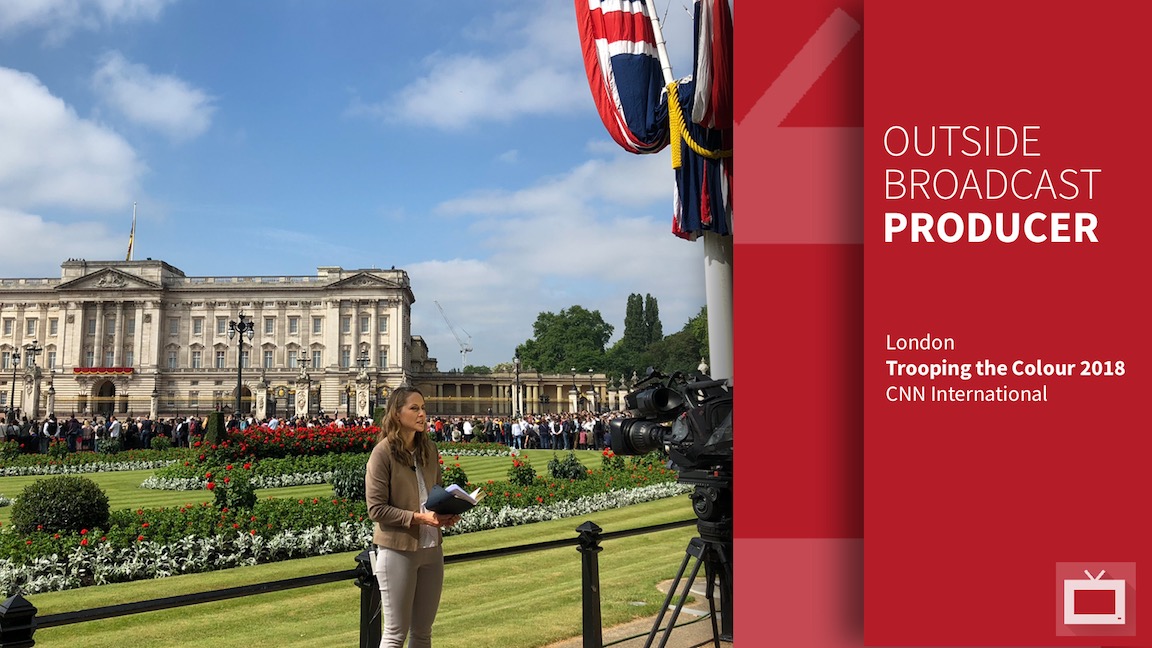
left=0, top=0, right=175, bottom=43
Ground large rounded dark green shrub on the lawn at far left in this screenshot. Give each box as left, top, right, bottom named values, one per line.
left=12, top=475, right=108, bottom=533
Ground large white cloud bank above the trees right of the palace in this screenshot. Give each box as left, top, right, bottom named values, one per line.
left=406, top=148, right=704, bottom=370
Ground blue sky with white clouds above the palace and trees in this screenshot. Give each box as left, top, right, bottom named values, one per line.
left=0, top=0, right=704, bottom=370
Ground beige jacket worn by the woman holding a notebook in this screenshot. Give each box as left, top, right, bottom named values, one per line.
left=364, top=439, right=444, bottom=551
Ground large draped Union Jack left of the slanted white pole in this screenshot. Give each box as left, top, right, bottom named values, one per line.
left=576, top=0, right=668, bottom=153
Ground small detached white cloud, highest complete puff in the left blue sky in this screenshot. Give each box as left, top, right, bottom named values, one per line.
left=92, top=52, right=215, bottom=141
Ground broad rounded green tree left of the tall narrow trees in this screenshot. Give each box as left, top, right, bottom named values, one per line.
left=516, top=306, right=613, bottom=374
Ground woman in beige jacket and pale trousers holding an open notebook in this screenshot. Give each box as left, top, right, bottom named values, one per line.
left=364, top=386, right=460, bottom=648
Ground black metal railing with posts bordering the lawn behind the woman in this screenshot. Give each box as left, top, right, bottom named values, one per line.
left=0, top=520, right=696, bottom=648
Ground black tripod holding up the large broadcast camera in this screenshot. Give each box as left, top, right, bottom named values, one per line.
left=644, top=470, right=733, bottom=648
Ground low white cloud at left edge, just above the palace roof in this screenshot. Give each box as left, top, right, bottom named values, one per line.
left=0, top=206, right=128, bottom=278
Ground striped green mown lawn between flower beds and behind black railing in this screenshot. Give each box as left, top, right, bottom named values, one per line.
left=0, top=451, right=696, bottom=648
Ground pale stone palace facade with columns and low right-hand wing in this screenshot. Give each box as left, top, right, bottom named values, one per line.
left=0, top=259, right=626, bottom=417
